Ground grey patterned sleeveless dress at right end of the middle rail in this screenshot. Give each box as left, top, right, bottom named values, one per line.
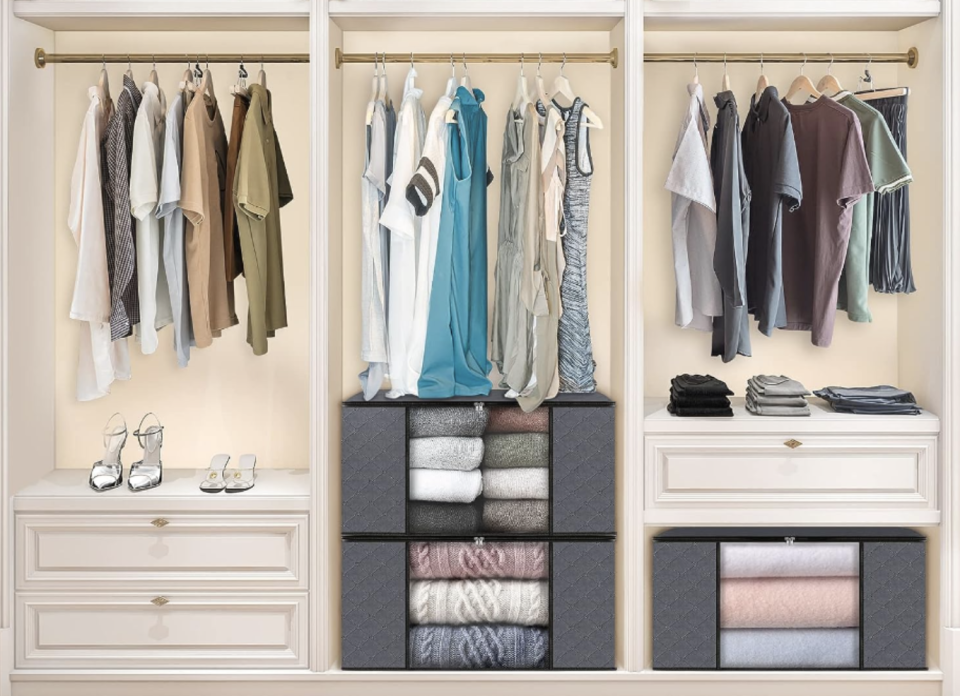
left=554, top=97, right=597, bottom=394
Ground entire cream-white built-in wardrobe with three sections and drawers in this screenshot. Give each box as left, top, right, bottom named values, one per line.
left=0, top=0, right=960, bottom=696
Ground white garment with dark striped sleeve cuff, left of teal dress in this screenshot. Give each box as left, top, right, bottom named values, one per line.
left=406, top=90, right=453, bottom=392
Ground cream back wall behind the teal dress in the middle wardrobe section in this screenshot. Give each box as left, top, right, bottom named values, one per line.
left=342, top=31, right=622, bottom=398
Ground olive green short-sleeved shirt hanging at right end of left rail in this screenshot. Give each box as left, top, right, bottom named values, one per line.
left=233, top=84, right=293, bottom=355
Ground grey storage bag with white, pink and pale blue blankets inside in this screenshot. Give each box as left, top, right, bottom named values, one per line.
left=653, top=527, right=926, bottom=670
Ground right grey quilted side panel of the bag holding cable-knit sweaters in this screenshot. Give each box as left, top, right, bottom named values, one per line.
left=550, top=541, right=615, bottom=669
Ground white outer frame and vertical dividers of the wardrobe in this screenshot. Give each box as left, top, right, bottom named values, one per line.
left=0, top=0, right=960, bottom=696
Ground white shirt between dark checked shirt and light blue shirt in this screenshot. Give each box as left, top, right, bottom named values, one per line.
left=130, top=82, right=173, bottom=355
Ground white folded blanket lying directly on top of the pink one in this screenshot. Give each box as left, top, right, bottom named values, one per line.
left=720, top=542, right=860, bottom=578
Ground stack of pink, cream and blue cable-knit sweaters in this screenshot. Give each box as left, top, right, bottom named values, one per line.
left=408, top=541, right=550, bottom=669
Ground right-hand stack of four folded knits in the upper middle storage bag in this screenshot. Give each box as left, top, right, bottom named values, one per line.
left=481, top=407, right=550, bottom=533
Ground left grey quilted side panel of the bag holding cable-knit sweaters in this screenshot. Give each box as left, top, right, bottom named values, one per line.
left=340, top=541, right=407, bottom=669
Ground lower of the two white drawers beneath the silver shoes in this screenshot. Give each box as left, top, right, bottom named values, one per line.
left=16, top=593, right=307, bottom=669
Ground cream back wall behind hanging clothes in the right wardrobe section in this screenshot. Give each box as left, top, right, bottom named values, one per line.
left=643, top=32, right=900, bottom=396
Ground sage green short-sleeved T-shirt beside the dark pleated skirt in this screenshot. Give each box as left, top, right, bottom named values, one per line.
left=833, top=92, right=913, bottom=322
